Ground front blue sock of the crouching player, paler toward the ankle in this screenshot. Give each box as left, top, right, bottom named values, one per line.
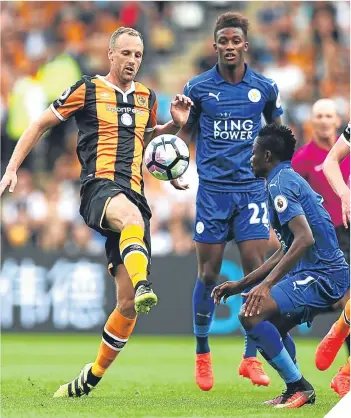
left=248, top=321, right=302, bottom=383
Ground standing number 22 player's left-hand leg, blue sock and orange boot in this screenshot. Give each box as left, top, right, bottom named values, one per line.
left=193, top=242, right=225, bottom=391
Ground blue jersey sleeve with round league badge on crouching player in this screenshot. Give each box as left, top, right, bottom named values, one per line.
left=269, top=178, right=305, bottom=225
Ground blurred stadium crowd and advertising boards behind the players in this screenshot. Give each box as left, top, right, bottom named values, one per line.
left=0, top=1, right=350, bottom=416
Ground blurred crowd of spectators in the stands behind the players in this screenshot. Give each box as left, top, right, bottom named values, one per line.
left=0, top=1, right=350, bottom=255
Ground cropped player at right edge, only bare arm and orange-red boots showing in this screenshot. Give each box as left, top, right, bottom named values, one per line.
left=315, top=122, right=351, bottom=398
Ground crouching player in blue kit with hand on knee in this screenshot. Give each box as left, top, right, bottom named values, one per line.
left=212, top=124, right=350, bottom=408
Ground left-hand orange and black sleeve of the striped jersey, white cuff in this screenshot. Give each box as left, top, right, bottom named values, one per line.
left=50, top=80, right=86, bottom=121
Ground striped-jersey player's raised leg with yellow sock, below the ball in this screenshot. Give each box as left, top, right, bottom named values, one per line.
left=104, top=193, right=157, bottom=313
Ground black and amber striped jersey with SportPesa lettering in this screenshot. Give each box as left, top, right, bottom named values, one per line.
left=50, top=75, right=157, bottom=194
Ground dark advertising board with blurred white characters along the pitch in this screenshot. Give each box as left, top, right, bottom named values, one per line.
left=0, top=246, right=338, bottom=337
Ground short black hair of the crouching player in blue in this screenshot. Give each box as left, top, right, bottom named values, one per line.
left=256, top=123, right=296, bottom=161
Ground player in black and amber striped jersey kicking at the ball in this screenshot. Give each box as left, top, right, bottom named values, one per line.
left=0, top=27, right=192, bottom=397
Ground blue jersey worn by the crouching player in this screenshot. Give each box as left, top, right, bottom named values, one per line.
left=268, top=161, right=347, bottom=274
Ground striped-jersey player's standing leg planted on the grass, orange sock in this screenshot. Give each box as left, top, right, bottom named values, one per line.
left=54, top=264, right=136, bottom=398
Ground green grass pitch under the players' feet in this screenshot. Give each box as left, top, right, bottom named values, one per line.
left=1, top=334, right=347, bottom=418
